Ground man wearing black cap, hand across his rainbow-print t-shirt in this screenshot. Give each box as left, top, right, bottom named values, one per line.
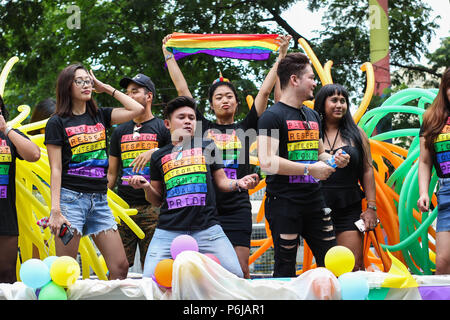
left=108, top=73, right=171, bottom=267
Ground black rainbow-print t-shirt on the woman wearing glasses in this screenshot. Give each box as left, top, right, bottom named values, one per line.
left=44, top=108, right=112, bottom=193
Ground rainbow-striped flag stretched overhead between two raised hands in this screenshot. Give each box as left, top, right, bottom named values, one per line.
left=166, top=32, right=279, bottom=60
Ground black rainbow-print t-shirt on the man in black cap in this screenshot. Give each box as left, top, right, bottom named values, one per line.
left=109, top=118, right=171, bottom=205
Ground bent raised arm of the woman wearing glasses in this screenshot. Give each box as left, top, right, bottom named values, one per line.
left=90, top=70, right=145, bottom=125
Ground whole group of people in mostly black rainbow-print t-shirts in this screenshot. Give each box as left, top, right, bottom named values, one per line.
left=0, top=35, right=450, bottom=283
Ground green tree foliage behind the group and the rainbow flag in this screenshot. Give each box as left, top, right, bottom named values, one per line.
left=0, top=0, right=442, bottom=118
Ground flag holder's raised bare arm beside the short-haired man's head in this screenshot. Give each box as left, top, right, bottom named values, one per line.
left=255, top=35, right=292, bottom=117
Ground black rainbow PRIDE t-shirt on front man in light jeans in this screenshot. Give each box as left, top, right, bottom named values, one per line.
left=150, top=140, right=223, bottom=230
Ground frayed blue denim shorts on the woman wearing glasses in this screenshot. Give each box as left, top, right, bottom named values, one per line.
left=60, top=188, right=117, bottom=236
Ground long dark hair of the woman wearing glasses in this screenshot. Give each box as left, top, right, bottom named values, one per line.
left=55, top=63, right=98, bottom=117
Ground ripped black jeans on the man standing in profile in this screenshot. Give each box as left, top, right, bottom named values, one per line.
left=264, top=196, right=336, bottom=278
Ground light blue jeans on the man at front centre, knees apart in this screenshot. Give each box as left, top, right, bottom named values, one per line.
left=143, top=224, right=244, bottom=278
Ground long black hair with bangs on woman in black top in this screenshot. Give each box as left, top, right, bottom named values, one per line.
left=314, top=84, right=366, bottom=163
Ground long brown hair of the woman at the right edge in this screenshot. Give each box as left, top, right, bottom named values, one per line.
left=422, top=67, right=450, bottom=152
